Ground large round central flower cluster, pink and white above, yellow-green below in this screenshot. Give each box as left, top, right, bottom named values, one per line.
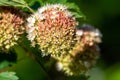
left=27, top=4, right=77, bottom=56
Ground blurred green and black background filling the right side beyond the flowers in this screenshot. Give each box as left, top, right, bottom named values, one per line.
left=71, top=0, right=120, bottom=80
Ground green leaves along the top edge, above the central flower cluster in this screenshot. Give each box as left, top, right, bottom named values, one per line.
left=0, top=0, right=85, bottom=19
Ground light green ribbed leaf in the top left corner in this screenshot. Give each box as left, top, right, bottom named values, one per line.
left=0, top=0, right=27, bottom=7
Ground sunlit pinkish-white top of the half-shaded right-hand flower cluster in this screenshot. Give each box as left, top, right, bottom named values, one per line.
left=76, top=24, right=102, bottom=46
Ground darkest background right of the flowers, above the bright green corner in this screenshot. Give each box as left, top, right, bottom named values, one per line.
left=70, top=0, right=120, bottom=65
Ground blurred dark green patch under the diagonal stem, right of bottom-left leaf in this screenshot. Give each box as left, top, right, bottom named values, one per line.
left=10, top=56, right=49, bottom=80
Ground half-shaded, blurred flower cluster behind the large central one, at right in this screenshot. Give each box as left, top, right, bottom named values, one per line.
left=57, top=24, right=101, bottom=75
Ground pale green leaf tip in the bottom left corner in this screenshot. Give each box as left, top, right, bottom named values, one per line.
left=0, top=72, right=19, bottom=80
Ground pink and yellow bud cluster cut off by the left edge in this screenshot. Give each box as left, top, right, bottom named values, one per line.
left=0, top=7, right=25, bottom=52
